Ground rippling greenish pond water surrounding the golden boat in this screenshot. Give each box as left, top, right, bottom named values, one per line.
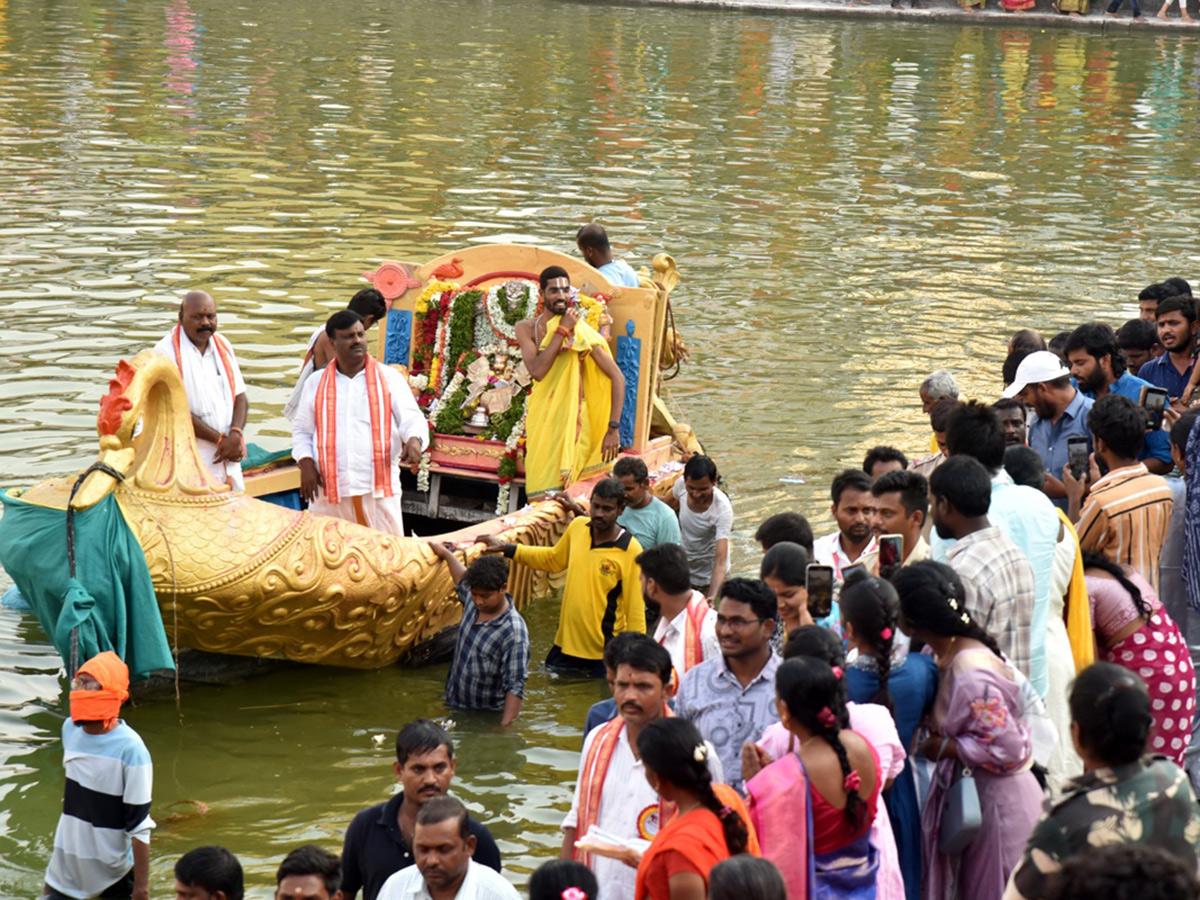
left=0, top=0, right=1198, bottom=895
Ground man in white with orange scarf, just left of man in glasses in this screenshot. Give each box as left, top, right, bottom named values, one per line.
left=635, top=544, right=721, bottom=685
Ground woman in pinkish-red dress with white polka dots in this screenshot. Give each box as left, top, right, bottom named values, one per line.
left=1084, top=553, right=1196, bottom=766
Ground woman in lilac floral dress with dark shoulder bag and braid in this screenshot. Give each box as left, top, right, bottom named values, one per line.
left=894, top=563, right=1043, bottom=900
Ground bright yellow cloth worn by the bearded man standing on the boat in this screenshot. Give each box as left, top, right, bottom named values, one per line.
left=526, top=317, right=612, bottom=498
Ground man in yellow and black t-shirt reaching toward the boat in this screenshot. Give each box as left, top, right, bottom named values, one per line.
left=479, top=478, right=646, bottom=678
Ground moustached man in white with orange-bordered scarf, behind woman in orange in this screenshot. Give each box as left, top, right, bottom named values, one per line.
left=562, top=635, right=720, bottom=900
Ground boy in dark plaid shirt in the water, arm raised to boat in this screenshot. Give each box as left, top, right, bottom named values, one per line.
left=430, top=541, right=529, bottom=725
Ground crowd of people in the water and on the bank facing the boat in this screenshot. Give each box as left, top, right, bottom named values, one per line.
left=46, top=280, right=1200, bottom=900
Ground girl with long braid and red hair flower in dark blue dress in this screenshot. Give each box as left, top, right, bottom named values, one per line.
left=841, top=575, right=937, bottom=900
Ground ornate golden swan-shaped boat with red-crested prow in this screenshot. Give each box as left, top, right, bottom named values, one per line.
left=0, top=245, right=698, bottom=668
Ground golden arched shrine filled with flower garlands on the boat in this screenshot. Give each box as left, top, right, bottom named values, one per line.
left=366, top=244, right=678, bottom=515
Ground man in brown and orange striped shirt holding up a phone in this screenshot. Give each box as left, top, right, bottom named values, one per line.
left=1063, top=394, right=1174, bottom=590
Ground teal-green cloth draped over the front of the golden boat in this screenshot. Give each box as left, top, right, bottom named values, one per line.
left=0, top=493, right=175, bottom=679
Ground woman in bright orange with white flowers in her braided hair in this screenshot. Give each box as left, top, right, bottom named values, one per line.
left=634, top=716, right=758, bottom=900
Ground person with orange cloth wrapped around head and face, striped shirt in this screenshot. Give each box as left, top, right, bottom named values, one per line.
left=43, top=652, right=154, bottom=900
